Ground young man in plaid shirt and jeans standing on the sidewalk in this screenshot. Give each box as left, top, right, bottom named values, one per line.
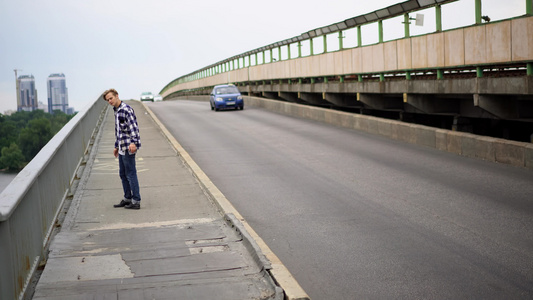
left=102, top=89, right=141, bottom=209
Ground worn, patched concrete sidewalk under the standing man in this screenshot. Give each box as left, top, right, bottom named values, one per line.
left=33, top=101, right=284, bottom=300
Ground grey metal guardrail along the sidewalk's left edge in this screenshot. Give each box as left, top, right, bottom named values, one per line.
left=0, top=97, right=107, bottom=300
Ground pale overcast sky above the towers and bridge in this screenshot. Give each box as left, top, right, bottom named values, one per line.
left=0, top=0, right=531, bottom=113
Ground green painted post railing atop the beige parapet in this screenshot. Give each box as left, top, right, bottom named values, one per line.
left=160, top=0, right=533, bottom=94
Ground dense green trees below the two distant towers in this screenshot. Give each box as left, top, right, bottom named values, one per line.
left=0, top=110, right=74, bottom=172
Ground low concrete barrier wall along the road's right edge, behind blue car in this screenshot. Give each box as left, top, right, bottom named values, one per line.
left=180, top=96, right=533, bottom=169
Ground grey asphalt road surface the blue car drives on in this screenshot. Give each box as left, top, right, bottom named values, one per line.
left=148, top=100, right=533, bottom=300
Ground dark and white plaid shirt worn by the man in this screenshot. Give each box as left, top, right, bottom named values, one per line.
left=113, top=102, right=141, bottom=153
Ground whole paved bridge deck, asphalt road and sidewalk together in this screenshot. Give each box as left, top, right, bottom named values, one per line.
left=28, top=97, right=533, bottom=299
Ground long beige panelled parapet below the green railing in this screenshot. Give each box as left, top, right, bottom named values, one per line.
left=161, top=16, right=533, bottom=97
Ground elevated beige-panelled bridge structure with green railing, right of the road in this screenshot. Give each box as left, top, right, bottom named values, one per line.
left=161, top=0, right=533, bottom=141
